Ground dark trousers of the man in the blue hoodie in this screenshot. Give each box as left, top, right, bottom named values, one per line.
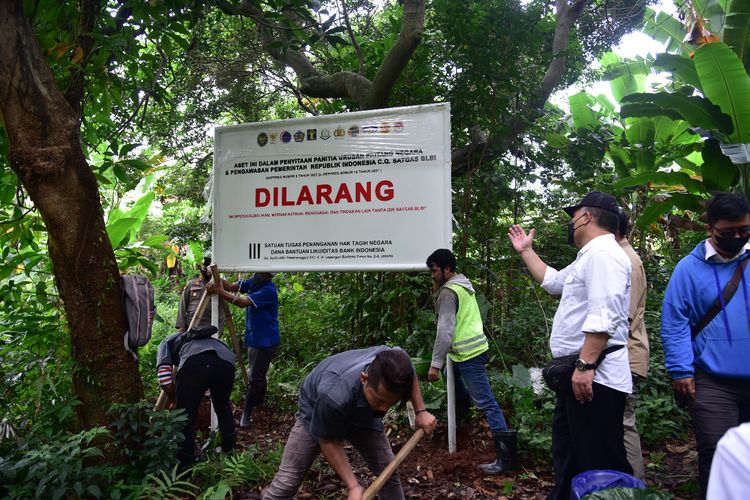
left=688, top=370, right=750, bottom=498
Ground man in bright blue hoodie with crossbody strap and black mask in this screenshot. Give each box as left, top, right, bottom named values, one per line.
left=661, top=193, right=750, bottom=497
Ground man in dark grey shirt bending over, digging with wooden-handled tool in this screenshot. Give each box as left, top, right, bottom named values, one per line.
left=263, top=346, right=436, bottom=500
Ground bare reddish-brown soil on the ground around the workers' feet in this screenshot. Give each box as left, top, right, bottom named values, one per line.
left=232, top=408, right=698, bottom=500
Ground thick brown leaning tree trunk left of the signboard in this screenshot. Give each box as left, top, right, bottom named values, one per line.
left=0, top=0, right=143, bottom=427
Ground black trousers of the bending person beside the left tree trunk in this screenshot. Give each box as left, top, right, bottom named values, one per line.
left=175, top=351, right=235, bottom=466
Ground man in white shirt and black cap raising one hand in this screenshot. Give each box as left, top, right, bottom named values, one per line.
left=508, top=191, right=632, bottom=499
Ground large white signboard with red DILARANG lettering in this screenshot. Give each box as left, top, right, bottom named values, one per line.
left=213, top=103, right=452, bottom=271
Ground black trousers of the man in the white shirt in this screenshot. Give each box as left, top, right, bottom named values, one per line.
left=547, top=383, right=633, bottom=500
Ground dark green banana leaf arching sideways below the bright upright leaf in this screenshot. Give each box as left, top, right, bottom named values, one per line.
left=620, top=92, right=736, bottom=134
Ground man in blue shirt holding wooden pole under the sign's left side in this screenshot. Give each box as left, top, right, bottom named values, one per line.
left=207, top=273, right=281, bottom=427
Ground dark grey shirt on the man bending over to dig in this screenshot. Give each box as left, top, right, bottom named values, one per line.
left=298, top=346, right=398, bottom=440
